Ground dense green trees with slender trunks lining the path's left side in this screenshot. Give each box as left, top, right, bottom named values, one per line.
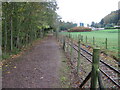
left=2, top=1, right=58, bottom=57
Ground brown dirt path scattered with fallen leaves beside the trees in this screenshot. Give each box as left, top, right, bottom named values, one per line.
left=2, top=35, right=63, bottom=88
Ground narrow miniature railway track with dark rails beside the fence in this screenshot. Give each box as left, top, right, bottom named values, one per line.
left=69, top=43, right=120, bottom=88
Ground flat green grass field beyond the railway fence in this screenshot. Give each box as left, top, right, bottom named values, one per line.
left=60, top=29, right=118, bottom=57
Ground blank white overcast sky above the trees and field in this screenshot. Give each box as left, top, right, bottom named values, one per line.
left=56, top=0, right=120, bottom=24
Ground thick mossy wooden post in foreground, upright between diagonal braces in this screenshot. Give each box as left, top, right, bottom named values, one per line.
left=91, top=48, right=100, bottom=90
